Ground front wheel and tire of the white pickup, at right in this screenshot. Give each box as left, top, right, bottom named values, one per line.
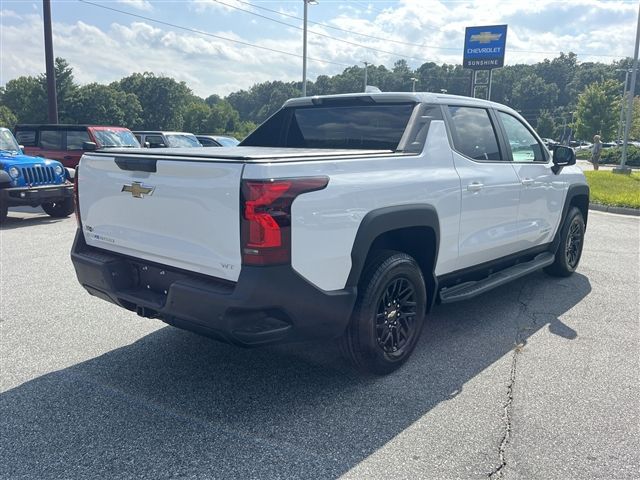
left=544, top=207, right=584, bottom=277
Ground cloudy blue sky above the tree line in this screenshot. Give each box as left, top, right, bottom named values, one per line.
left=0, top=0, right=639, bottom=97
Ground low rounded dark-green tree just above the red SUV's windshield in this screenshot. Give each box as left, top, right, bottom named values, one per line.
left=67, top=83, right=142, bottom=128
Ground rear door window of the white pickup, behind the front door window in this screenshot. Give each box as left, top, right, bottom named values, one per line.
left=449, top=106, right=503, bottom=160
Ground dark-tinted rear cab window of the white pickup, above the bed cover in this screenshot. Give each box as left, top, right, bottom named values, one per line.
left=241, top=102, right=415, bottom=150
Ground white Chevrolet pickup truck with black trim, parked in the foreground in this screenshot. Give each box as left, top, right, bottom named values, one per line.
left=71, top=93, right=589, bottom=374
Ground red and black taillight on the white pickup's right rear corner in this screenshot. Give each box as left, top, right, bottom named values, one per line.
left=240, top=177, right=329, bottom=265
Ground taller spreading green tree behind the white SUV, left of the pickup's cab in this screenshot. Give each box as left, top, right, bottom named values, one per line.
left=117, top=72, right=193, bottom=130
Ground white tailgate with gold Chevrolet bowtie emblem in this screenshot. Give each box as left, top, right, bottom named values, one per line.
left=78, top=154, right=243, bottom=281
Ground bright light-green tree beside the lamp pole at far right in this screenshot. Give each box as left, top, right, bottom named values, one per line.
left=572, top=80, right=620, bottom=140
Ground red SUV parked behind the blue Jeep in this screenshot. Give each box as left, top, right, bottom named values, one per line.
left=14, top=124, right=140, bottom=168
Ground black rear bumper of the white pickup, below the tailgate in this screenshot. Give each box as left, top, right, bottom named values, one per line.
left=71, top=231, right=356, bottom=346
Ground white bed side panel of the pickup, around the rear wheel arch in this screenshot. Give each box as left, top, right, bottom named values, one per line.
left=243, top=121, right=460, bottom=290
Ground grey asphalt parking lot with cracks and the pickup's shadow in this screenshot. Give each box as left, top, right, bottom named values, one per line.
left=0, top=211, right=640, bottom=479
